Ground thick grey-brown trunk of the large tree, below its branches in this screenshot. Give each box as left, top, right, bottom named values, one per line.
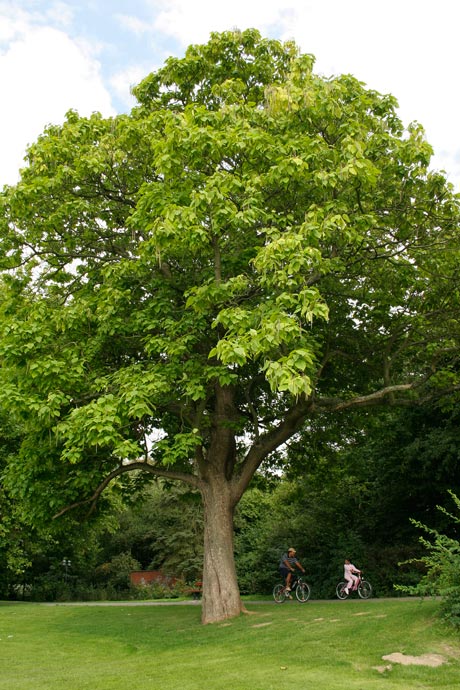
left=201, top=473, right=243, bottom=623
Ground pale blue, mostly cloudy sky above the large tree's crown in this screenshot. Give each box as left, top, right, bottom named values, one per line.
left=0, top=0, right=460, bottom=192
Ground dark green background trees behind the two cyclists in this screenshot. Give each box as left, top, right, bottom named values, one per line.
left=246, top=403, right=460, bottom=598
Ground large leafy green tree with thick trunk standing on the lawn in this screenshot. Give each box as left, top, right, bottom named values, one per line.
left=0, top=30, right=459, bottom=622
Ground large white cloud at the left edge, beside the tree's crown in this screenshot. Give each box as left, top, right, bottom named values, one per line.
left=0, top=23, right=114, bottom=186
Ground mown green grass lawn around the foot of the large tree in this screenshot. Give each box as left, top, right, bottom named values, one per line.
left=0, top=599, right=460, bottom=690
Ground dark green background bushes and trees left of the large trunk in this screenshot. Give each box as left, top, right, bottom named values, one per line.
left=0, top=487, right=203, bottom=601
